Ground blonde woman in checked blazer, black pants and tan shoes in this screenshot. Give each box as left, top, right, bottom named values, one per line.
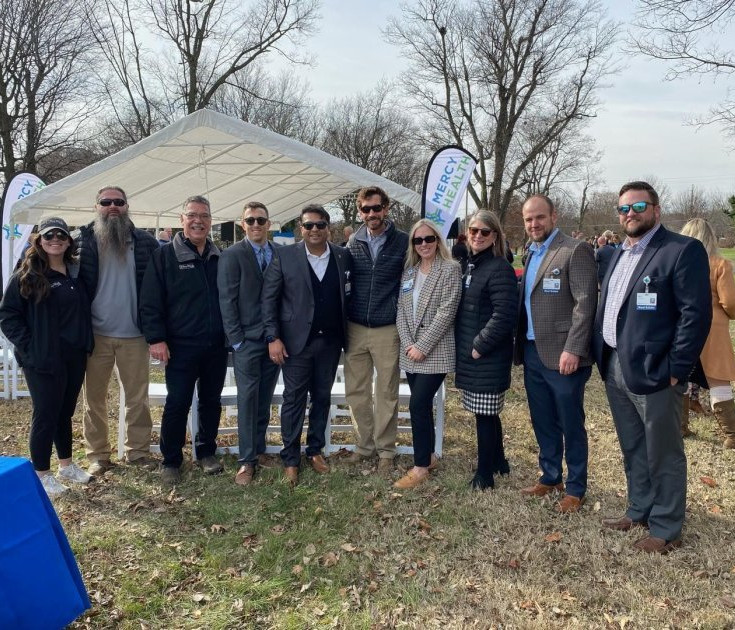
left=394, top=219, right=462, bottom=488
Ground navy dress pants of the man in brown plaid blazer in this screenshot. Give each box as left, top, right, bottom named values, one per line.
left=523, top=341, right=592, bottom=497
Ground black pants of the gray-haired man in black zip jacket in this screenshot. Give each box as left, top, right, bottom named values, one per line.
left=160, top=344, right=227, bottom=468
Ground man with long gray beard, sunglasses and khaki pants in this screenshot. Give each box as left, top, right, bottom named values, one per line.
left=74, top=186, right=159, bottom=475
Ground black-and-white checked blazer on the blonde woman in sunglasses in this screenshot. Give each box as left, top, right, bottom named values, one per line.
left=396, top=256, right=462, bottom=374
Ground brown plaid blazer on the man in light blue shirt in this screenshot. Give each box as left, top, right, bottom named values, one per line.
left=516, top=232, right=597, bottom=370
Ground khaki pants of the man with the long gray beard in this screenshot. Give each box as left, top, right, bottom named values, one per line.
left=83, top=335, right=152, bottom=462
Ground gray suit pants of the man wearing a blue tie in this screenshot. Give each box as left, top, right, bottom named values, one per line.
left=232, top=339, right=280, bottom=465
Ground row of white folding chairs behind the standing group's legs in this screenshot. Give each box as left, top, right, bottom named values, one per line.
left=118, top=365, right=446, bottom=459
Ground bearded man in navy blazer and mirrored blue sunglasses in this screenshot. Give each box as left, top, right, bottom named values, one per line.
left=593, top=182, right=712, bottom=553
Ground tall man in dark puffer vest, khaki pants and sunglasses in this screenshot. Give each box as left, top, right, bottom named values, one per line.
left=345, top=186, right=408, bottom=472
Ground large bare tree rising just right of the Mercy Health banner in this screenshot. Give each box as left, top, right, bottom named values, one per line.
left=387, top=0, right=618, bottom=225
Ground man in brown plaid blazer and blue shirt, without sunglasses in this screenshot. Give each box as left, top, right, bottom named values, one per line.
left=515, top=195, right=597, bottom=514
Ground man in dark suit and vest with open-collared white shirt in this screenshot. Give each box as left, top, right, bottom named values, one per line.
left=263, top=205, right=352, bottom=485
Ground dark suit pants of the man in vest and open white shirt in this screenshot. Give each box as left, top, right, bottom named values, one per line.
left=281, top=337, right=342, bottom=466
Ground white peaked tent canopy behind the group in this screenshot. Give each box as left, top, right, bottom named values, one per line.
left=12, top=110, right=421, bottom=227
